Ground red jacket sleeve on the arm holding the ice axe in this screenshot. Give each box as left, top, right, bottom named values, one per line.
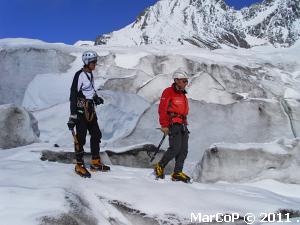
left=158, top=89, right=171, bottom=127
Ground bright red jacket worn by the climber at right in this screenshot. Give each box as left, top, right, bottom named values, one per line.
left=158, top=84, right=189, bottom=127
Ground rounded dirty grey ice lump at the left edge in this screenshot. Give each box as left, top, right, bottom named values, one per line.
left=0, top=104, right=40, bottom=149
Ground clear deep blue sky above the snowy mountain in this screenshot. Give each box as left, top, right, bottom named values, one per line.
left=0, top=0, right=261, bottom=44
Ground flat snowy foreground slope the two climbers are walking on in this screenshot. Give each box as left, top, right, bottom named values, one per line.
left=0, top=144, right=300, bottom=225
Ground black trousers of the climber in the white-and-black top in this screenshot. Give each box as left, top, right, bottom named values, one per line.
left=75, top=114, right=102, bottom=163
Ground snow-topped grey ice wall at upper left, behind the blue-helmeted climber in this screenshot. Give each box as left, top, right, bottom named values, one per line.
left=0, top=39, right=75, bottom=105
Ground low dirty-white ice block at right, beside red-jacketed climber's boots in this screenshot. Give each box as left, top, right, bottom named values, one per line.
left=194, top=138, right=300, bottom=184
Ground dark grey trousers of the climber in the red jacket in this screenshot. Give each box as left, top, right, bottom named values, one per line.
left=159, top=123, right=189, bottom=173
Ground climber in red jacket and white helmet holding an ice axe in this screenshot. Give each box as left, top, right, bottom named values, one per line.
left=154, top=69, right=190, bottom=183
